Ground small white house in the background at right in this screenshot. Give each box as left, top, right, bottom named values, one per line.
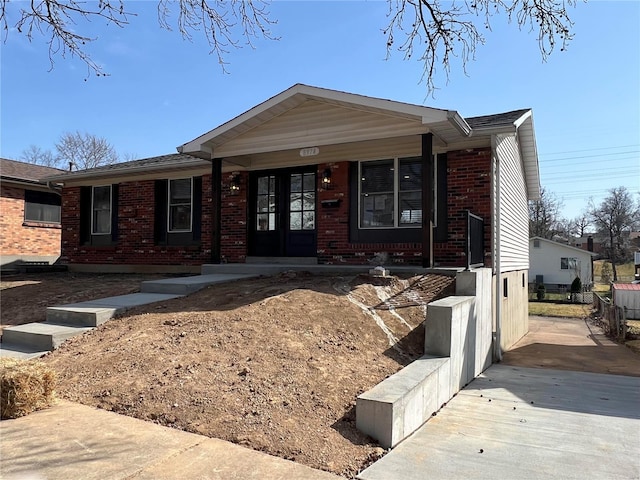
left=529, top=237, right=596, bottom=289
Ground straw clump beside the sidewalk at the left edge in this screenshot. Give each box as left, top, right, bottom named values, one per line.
left=0, top=358, right=56, bottom=420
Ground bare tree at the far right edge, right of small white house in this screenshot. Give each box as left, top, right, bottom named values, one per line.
left=589, top=187, right=640, bottom=282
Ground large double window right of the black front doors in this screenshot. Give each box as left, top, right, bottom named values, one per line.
left=359, top=157, right=422, bottom=228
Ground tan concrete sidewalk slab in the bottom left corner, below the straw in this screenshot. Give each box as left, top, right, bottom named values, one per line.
left=0, top=401, right=341, bottom=480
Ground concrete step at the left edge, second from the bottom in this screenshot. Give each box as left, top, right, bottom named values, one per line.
left=2, top=322, right=91, bottom=352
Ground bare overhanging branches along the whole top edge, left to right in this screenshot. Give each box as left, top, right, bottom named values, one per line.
left=0, top=0, right=578, bottom=92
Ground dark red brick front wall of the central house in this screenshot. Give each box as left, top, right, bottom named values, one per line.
left=62, top=144, right=491, bottom=266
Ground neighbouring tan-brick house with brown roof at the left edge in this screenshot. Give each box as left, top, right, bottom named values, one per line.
left=0, top=158, right=63, bottom=269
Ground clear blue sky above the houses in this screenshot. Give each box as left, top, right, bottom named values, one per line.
left=0, top=0, right=640, bottom=218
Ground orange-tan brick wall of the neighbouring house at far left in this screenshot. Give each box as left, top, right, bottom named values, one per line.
left=0, top=185, right=61, bottom=257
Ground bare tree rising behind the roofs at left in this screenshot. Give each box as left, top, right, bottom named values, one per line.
left=56, top=132, right=118, bottom=170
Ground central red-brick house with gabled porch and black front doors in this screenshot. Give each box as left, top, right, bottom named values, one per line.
left=43, top=84, right=540, bottom=350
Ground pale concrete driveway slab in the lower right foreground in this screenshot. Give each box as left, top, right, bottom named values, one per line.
left=358, top=365, right=640, bottom=480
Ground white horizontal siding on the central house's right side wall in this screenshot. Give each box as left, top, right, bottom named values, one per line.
left=496, top=134, right=529, bottom=272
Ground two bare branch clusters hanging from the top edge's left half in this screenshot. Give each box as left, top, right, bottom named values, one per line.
left=0, top=0, right=275, bottom=76
